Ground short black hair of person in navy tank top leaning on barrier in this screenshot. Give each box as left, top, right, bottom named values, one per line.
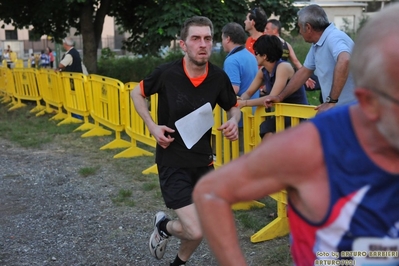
left=253, top=35, right=283, bottom=63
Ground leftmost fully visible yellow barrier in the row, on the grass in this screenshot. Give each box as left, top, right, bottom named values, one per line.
left=9, top=68, right=45, bottom=113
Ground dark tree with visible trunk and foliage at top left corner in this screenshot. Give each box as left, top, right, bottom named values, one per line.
left=0, top=0, right=111, bottom=73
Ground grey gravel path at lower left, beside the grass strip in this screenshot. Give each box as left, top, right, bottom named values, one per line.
left=0, top=139, right=223, bottom=266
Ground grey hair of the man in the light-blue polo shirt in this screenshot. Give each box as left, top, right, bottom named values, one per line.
left=298, top=4, right=330, bottom=31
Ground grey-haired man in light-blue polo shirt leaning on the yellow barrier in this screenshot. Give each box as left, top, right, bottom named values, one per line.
left=265, top=4, right=355, bottom=112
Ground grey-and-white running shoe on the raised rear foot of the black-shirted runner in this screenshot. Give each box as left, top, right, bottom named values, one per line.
left=149, top=212, right=169, bottom=260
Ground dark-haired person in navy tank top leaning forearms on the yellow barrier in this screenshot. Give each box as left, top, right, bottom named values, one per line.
left=239, top=35, right=308, bottom=138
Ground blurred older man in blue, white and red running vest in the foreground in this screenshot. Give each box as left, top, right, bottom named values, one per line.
left=194, top=4, right=399, bottom=266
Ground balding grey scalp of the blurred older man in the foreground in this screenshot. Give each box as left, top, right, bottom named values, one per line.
left=351, top=4, right=399, bottom=89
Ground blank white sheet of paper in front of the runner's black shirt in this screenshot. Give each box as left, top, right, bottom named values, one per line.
left=175, top=103, right=214, bottom=149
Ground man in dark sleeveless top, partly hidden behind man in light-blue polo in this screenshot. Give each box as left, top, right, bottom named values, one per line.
left=265, top=19, right=316, bottom=89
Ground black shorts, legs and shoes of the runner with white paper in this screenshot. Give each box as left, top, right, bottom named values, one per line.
left=150, top=165, right=214, bottom=266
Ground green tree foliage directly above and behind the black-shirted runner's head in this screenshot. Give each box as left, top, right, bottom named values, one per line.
left=113, top=0, right=297, bottom=55
